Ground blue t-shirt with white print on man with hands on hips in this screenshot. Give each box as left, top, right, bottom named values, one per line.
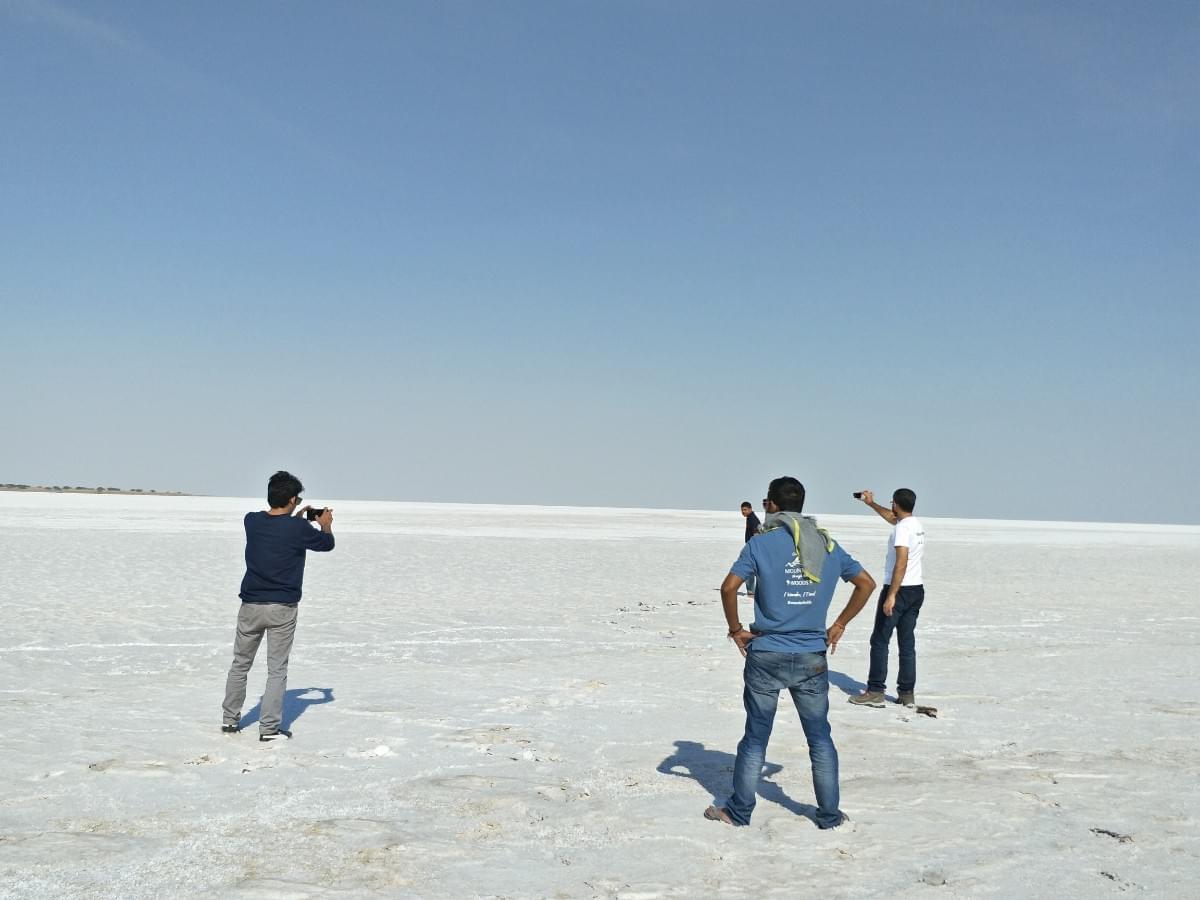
left=730, top=528, right=863, bottom=653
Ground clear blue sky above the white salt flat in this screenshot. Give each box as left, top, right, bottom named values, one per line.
left=0, top=0, right=1200, bottom=523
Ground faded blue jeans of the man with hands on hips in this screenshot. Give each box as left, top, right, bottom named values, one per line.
left=725, top=644, right=841, bottom=828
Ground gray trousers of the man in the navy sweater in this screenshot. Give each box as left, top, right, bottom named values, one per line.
left=221, top=604, right=299, bottom=734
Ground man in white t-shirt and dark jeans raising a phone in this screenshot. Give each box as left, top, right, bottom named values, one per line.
left=850, top=487, right=925, bottom=707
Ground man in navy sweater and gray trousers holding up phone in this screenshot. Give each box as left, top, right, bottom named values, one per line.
left=221, top=472, right=334, bottom=740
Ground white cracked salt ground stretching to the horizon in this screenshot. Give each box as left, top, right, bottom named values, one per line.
left=0, top=494, right=1200, bottom=900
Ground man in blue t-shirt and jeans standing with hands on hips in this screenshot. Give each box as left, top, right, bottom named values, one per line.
left=704, top=476, right=875, bottom=828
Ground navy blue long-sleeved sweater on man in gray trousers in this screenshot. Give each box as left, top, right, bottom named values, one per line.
left=239, top=512, right=334, bottom=604
